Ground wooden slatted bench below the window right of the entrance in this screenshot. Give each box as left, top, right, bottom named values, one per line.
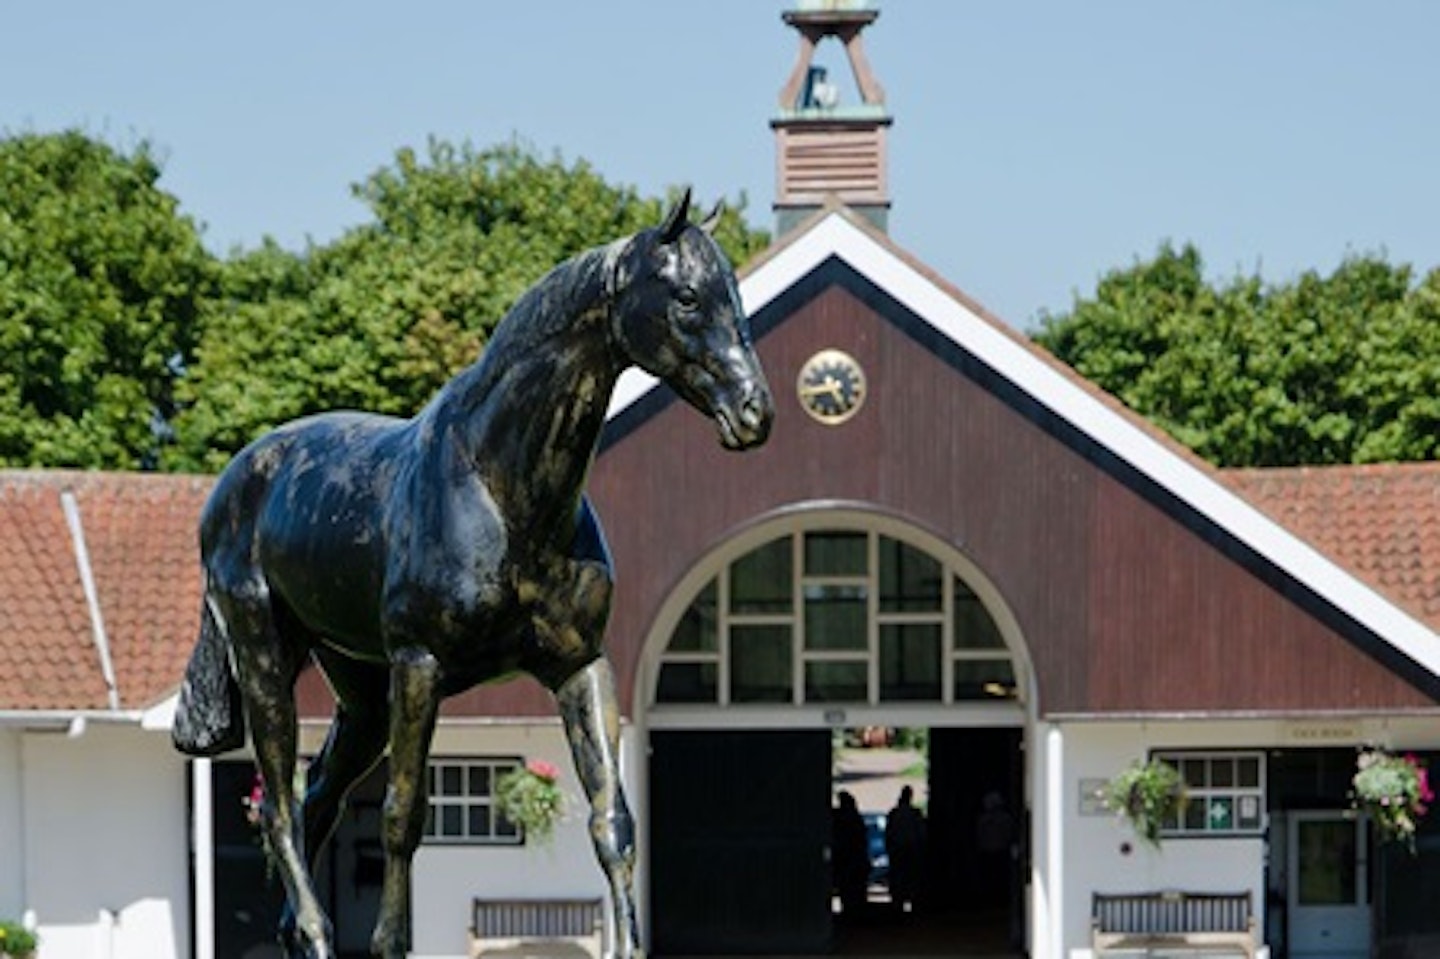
left=1090, top=890, right=1259, bottom=959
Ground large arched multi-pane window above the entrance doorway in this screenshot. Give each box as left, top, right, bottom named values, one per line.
left=655, top=528, right=1015, bottom=706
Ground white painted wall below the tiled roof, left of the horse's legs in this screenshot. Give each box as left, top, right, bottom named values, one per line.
left=19, top=720, right=190, bottom=959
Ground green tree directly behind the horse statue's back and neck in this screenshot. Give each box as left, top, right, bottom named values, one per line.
left=170, top=140, right=769, bottom=469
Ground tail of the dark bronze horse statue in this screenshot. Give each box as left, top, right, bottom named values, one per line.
left=170, top=596, right=245, bottom=756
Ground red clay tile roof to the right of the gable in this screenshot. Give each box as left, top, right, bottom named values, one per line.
left=1220, top=462, right=1440, bottom=631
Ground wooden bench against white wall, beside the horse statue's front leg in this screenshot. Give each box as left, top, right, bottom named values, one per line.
left=469, top=899, right=605, bottom=959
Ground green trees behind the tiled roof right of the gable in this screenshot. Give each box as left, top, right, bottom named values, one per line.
left=1035, top=245, right=1440, bottom=467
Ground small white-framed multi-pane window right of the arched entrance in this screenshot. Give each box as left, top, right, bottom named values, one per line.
left=1155, top=752, right=1266, bottom=837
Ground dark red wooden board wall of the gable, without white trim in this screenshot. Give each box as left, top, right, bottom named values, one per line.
left=414, top=261, right=1434, bottom=714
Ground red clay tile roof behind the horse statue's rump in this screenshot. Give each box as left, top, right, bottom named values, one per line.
left=0, top=471, right=213, bottom=711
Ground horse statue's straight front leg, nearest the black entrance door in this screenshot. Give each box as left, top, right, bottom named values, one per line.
left=556, top=657, right=644, bottom=959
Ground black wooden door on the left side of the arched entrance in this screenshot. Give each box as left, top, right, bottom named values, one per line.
left=649, top=730, right=831, bottom=956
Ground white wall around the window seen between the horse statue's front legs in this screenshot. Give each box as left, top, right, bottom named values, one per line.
left=412, top=721, right=642, bottom=956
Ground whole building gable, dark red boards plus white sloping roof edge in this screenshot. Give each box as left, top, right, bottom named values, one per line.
left=592, top=212, right=1440, bottom=714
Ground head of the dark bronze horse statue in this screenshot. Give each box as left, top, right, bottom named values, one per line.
left=612, top=190, right=775, bottom=449
